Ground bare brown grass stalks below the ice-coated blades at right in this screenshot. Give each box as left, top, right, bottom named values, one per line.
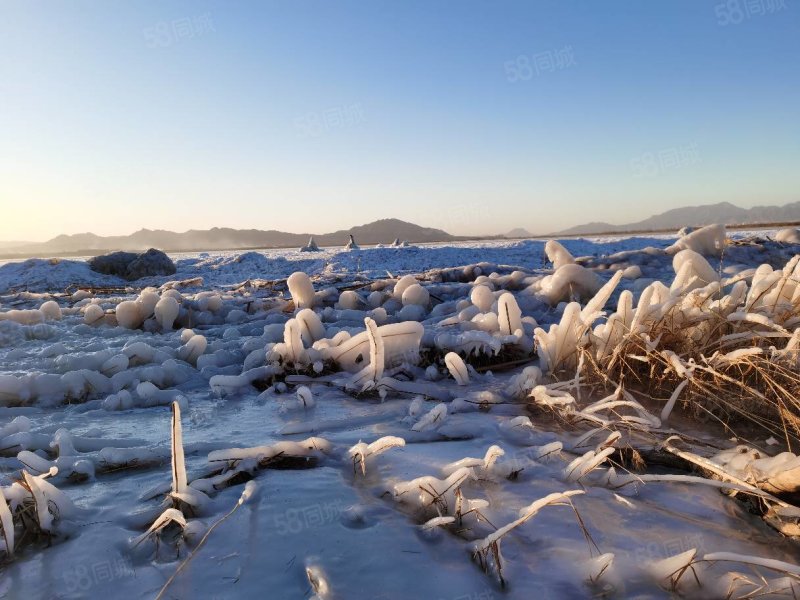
left=579, top=302, right=800, bottom=448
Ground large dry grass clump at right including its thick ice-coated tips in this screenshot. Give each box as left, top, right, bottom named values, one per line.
left=537, top=255, right=800, bottom=449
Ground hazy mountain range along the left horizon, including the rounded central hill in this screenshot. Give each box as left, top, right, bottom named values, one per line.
left=0, top=219, right=459, bottom=256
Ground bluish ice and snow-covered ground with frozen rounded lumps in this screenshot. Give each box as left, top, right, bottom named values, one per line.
left=0, top=231, right=800, bottom=600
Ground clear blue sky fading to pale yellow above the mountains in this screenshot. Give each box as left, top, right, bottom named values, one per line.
left=0, top=0, right=800, bottom=241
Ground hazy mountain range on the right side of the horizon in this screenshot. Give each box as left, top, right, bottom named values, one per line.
left=553, top=202, right=800, bottom=235
